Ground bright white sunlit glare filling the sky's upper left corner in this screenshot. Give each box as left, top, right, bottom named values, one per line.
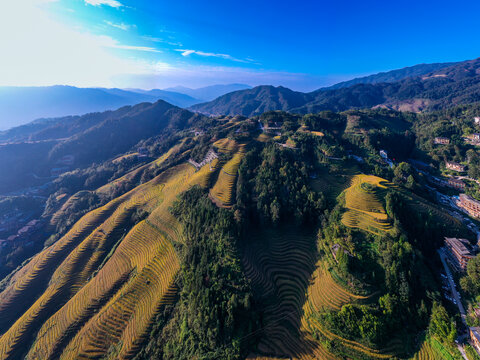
left=0, top=0, right=166, bottom=86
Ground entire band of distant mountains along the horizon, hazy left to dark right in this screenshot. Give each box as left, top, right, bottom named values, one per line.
left=0, top=59, right=480, bottom=132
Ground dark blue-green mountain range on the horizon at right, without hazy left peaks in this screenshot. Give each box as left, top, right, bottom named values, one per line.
left=190, top=59, right=480, bottom=116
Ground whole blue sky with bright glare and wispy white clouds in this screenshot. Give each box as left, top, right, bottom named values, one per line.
left=0, top=0, right=480, bottom=91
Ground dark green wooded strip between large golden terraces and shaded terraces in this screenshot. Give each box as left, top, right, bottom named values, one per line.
left=139, top=188, right=255, bottom=359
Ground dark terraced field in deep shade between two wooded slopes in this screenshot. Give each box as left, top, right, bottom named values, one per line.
left=243, top=229, right=335, bottom=360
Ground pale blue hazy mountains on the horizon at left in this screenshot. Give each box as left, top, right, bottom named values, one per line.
left=0, top=84, right=249, bottom=131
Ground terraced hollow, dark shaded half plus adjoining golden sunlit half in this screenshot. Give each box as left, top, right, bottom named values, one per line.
left=243, top=225, right=401, bottom=360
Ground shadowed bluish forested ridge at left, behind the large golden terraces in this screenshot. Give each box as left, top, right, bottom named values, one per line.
left=0, top=100, right=201, bottom=192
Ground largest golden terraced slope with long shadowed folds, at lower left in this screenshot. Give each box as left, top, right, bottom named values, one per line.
left=0, top=164, right=199, bottom=359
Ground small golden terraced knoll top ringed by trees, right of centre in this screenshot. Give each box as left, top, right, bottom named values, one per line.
left=342, top=174, right=393, bottom=234
